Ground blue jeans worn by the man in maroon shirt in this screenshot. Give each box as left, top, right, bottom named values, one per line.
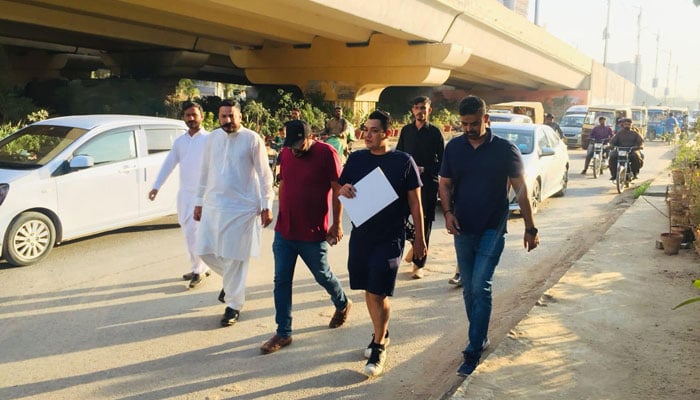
left=272, top=232, right=348, bottom=338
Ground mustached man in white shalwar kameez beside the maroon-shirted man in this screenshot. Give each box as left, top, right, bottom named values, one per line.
left=194, top=100, right=274, bottom=326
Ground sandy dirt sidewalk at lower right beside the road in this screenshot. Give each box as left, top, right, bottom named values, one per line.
left=453, top=182, right=700, bottom=400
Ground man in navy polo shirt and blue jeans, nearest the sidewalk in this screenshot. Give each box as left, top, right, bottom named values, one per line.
left=440, top=96, right=539, bottom=376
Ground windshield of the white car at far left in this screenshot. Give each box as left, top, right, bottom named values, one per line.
left=0, top=125, right=87, bottom=169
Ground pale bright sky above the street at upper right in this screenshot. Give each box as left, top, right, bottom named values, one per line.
left=528, top=0, right=700, bottom=100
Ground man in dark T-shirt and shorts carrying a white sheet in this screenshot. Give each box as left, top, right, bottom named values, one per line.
left=339, top=110, right=426, bottom=377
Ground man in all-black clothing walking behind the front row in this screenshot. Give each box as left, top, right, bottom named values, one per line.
left=396, top=96, right=445, bottom=279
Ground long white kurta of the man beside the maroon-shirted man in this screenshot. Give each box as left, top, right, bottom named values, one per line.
left=195, top=127, right=274, bottom=261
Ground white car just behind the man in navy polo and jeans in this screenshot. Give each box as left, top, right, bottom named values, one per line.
left=491, top=122, right=569, bottom=213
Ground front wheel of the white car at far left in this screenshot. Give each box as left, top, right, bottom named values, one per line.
left=3, top=211, right=56, bottom=265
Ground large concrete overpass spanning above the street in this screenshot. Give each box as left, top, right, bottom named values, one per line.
left=0, top=0, right=633, bottom=108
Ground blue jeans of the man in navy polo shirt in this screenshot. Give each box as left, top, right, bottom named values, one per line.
left=454, top=229, right=505, bottom=356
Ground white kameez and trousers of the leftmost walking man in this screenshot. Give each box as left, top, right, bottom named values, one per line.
left=153, top=128, right=209, bottom=274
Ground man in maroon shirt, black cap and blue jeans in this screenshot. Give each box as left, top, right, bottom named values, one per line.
left=260, top=120, right=352, bottom=354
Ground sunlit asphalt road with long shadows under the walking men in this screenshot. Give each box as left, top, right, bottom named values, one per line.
left=0, top=142, right=672, bottom=400
